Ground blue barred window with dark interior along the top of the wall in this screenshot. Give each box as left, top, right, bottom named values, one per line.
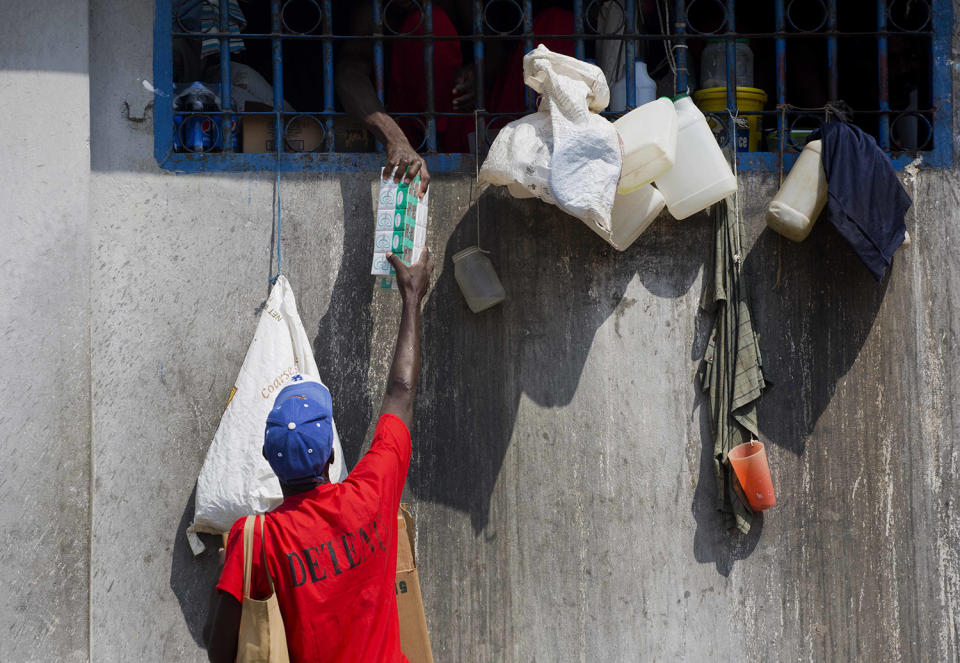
left=154, top=0, right=953, bottom=173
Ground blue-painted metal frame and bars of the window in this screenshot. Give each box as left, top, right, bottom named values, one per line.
left=153, top=0, right=953, bottom=174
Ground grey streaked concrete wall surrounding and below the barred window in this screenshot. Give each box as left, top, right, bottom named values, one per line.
left=0, top=0, right=960, bottom=661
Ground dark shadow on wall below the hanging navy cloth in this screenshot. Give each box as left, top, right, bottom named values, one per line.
left=744, top=223, right=899, bottom=455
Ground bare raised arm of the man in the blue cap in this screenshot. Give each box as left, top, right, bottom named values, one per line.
left=380, top=248, right=433, bottom=430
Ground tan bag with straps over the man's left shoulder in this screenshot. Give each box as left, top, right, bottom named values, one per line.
left=237, top=514, right=290, bottom=663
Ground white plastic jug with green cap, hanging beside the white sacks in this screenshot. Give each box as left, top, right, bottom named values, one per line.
left=654, top=95, right=737, bottom=219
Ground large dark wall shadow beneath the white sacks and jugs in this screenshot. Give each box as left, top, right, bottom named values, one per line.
left=409, top=189, right=700, bottom=533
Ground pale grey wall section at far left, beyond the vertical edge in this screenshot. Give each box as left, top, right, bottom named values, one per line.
left=0, top=0, right=91, bottom=661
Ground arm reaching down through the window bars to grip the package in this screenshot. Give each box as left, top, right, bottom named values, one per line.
left=336, top=3, right=430, bottom=198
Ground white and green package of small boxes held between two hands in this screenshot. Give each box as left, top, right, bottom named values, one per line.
left=370, top=168, right=430, bottom=290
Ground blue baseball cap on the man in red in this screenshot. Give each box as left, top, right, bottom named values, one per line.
left=263, top=375, right=333, bottom=484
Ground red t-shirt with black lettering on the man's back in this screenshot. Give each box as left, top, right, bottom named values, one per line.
left=217, top=414, right=410, bottom=663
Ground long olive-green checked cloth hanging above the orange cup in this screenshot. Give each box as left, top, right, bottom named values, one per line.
left=700, top=197, right=766, bottom=534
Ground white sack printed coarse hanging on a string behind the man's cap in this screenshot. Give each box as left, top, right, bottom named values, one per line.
left=187, top=276, right=346, bottom=555
